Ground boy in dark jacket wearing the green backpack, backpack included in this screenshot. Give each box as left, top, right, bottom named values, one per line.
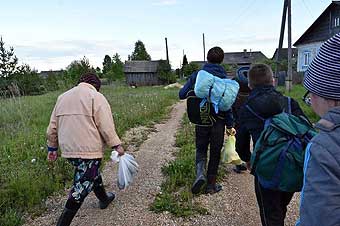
left=236, top=64, right=311, bottom=226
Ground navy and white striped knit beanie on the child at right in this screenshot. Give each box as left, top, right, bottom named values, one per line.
left=303, top=33, right=340, bottom=100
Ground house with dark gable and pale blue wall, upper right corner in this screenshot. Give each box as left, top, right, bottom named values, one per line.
left=294, top=1, right=340, bottom=72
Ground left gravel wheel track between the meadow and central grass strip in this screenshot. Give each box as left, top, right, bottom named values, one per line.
left=26, top=102, right=185, bottom=226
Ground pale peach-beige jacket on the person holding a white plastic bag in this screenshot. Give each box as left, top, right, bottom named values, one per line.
left=47, top=83, right=121, bottom=159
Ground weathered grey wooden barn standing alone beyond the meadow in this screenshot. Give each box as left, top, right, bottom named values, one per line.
left=124, top=60, right=164, bottom=86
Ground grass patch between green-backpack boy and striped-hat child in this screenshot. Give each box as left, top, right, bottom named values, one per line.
left=278, top=85, right=320, bottom=123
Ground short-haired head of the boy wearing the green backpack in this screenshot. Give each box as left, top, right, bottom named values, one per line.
left=248, top=64, right=274, bottom=89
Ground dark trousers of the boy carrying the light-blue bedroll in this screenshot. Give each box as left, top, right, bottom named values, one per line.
left=195, top=119, right=225, bottom=175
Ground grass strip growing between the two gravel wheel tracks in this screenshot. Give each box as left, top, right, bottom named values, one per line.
left=150, top=115, right=208, bottom=217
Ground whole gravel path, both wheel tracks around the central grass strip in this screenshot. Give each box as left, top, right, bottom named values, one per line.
left=26, top=102, right=298, bottom=226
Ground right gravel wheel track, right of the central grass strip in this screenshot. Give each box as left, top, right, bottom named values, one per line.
left=187, top=166, right=299, bottom=226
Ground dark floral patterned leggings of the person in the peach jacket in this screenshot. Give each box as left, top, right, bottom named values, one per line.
left=68, top=159, right=103, bottom=203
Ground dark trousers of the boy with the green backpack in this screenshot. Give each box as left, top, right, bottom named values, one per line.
left=255, top=177, right=294, bottom=226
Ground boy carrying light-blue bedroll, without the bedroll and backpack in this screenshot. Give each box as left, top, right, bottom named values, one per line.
left=179, top=47, right=233, bottom=194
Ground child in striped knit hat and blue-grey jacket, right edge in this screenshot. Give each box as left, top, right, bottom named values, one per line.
left=296, top=33, right=340, bottom=226
